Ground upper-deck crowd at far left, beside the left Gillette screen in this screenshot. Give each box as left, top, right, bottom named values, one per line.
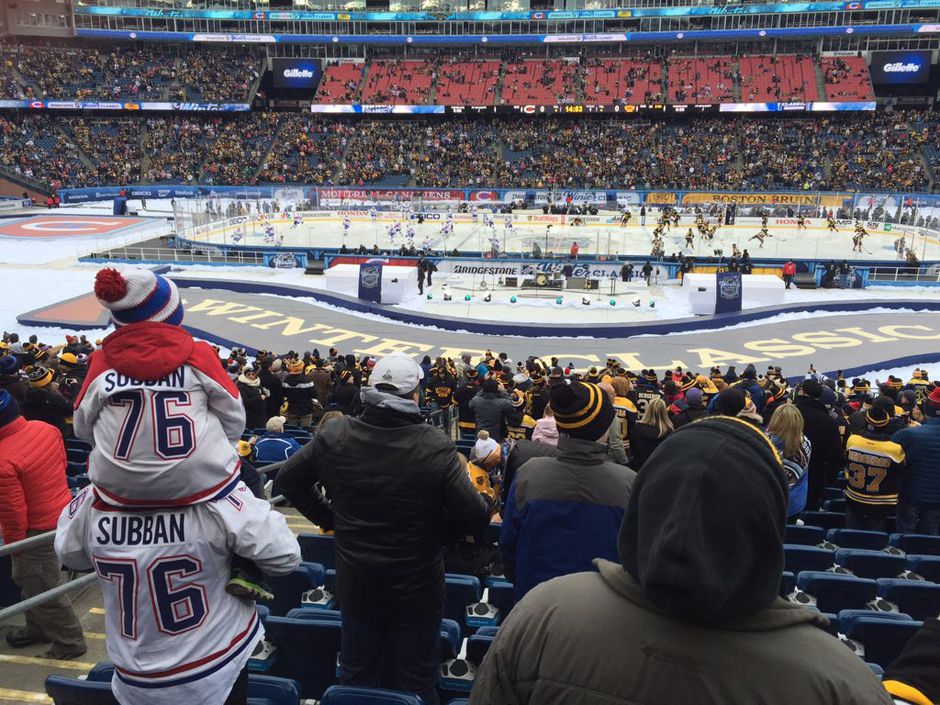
left=0, top=45, right=262, bottom=102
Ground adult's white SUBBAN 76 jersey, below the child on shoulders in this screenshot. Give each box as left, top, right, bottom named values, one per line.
left=55, top=483, right=300, bottom=705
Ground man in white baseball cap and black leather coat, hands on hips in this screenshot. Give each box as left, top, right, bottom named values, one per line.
left=275, top=353, right=490, bottom=705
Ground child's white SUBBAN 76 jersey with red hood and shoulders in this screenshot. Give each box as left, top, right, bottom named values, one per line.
left=73, top=323, right=245, bottom=507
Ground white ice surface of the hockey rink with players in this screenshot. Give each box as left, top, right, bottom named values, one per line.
left=177, top=211, right=940, bottom=261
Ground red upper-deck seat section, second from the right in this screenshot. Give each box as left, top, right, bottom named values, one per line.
left=738, top=55, right=819, bottom=103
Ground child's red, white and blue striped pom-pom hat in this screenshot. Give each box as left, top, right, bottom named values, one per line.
left=95, top=269, right=183, bottom=327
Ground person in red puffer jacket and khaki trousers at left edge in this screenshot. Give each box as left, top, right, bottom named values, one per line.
left=0, top=390, right=86, bottom=659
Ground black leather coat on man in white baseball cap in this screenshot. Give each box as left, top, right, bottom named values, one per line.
left=275, top=388, right=490, bottom=617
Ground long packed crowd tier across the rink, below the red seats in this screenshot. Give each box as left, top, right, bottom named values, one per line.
left=0, top=110, right=940, bottom=191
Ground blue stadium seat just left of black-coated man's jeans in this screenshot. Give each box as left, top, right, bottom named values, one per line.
left=265, top=617, right=342, bottom=699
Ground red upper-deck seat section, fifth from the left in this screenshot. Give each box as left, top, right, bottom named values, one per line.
left=584, top=59, right=664, bottom=105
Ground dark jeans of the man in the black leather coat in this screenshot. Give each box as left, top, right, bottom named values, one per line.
left=340, top=612, right=442, bottom=705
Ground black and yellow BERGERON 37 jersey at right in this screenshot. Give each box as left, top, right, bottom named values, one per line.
left=845, top=432, right=904, bottom=506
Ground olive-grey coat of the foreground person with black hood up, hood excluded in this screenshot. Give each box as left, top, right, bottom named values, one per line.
left=470, top=560, right=892, bottom=705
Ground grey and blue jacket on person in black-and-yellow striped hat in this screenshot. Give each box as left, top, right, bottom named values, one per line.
left=499, top=437, right=636, bottom=600
